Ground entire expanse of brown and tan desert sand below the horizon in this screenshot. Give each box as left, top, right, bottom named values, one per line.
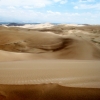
left=0, top=23, right=100, bottom=100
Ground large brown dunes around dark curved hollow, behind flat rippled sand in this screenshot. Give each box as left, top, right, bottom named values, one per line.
left=0, top=25, right=100, bottom=60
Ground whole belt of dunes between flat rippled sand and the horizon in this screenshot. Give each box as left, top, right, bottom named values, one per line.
left=0, top=24, right=100, bottom=60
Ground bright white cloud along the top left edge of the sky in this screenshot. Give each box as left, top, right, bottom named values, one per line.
left=0, top=0, right=52, bottom=7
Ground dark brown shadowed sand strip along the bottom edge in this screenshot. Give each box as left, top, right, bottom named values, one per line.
left=0, top=84, right=100, bottom=100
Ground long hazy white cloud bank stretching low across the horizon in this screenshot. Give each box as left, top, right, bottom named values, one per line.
left=0, top=9, right=100, bottom=24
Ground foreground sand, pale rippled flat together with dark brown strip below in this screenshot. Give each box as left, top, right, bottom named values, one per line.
left=0, top=60, right=100, bottom=100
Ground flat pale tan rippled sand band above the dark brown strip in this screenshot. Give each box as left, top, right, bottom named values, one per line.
left=0, top=60, right=100, bottom=88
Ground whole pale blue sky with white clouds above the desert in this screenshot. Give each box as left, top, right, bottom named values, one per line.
left=0, top=0, right=100, bottom=24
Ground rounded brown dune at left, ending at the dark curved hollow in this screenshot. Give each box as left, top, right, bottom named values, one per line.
left=0, top=30, right=63, bottom=51
